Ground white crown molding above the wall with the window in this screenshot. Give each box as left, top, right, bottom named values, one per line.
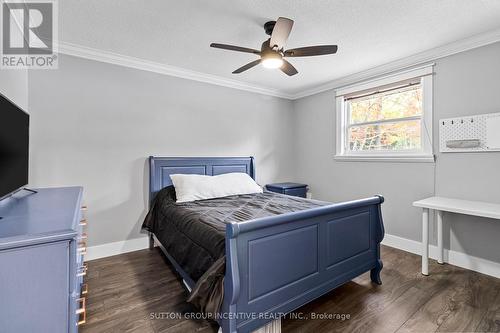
left=292, top=29, right=500, bottom=100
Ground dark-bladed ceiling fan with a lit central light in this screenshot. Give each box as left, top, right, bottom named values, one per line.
left=210, top=17, right=337, bottom=76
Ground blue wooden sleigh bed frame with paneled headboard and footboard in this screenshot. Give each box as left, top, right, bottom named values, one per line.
left=149, top=157, right=384, bottom=333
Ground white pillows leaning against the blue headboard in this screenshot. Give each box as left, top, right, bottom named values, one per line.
left=170, top=172, right=262, bottom=202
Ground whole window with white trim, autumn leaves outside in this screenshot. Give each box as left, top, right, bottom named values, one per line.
left=336, top=66, right=434, bottom=162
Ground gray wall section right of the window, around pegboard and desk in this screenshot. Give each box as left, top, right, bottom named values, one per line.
left=434, top=43, right=500, bottom=262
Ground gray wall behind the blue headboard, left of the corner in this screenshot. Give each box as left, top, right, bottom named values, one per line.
left=29, top=56, right=293, bottom=246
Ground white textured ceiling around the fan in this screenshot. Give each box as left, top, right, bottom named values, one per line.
left=59, top=0, right=500, bottom=94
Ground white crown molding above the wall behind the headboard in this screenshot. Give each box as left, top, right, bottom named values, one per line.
left=57, top=42, right=293, bottom=99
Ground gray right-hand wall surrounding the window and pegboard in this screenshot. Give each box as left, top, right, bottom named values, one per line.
left=294, top=43, right=500, bottom=262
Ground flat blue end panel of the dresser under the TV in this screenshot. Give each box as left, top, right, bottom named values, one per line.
left=0, top=241, right=70, bottom=333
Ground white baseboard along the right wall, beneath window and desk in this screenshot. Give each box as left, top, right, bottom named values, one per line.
left=382, top=234, right=500, bottom=278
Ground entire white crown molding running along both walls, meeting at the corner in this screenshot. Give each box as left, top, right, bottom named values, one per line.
left=54, top=29, right=500, bottom=100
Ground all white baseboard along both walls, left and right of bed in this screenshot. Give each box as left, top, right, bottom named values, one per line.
left=85, top=234, right=500, bottom=278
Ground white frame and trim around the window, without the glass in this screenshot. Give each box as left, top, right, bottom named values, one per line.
left=335, top=64, right=434, bottom=162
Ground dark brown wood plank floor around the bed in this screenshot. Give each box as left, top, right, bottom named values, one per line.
left=81, top=247, right=500, bottom=333
